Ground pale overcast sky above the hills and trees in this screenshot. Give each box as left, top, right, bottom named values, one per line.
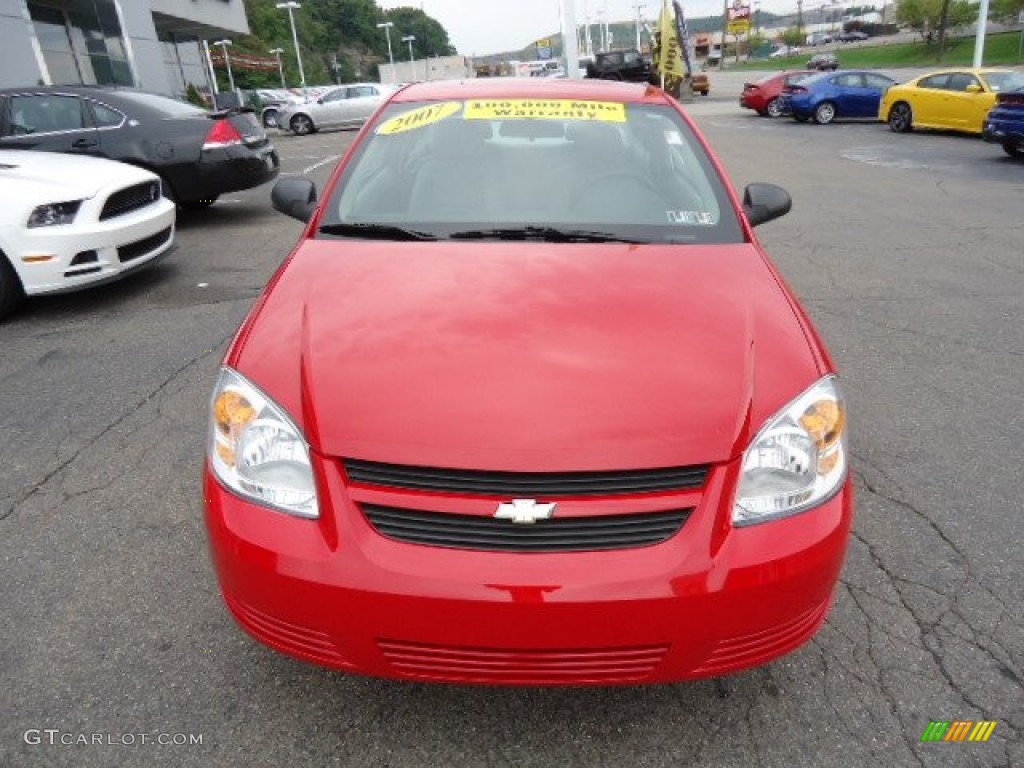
left=378, top=0, right=798, bottom=55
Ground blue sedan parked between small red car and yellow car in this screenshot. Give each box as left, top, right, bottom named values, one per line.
left=782, top=70, right=896, bottom=125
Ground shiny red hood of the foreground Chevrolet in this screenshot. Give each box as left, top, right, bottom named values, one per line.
left=228, top=240, right=821, bottom=471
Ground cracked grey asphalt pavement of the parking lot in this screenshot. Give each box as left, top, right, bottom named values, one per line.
left=0, top=97, right=1024, bottom=768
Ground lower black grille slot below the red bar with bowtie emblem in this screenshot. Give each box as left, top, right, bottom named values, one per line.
left=360, top=504, right=693, bottom=552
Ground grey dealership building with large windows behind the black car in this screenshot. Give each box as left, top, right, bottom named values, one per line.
left=0, top=0, right=249, bottom=96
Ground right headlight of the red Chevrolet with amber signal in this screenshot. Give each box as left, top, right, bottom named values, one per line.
left=732, top=376, right=847, bottom=525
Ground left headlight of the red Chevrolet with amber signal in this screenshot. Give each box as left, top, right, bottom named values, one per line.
left=208, top=368, right=319, bottom=518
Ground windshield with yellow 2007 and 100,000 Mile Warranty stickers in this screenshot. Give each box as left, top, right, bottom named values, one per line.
left=321, top=99, right=743, bottom=243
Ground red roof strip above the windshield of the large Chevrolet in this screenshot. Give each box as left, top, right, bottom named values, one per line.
left=392, top=78, right=666, bottom=103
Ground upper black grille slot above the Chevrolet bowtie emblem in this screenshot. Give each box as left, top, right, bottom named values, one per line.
left=344, top=459, right=708, bottom=499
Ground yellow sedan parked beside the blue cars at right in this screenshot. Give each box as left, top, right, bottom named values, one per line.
left=879, top=68, right=1024, bottom=135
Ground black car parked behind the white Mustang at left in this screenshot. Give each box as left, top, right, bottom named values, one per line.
left=0, top=85, right=280, bottom=208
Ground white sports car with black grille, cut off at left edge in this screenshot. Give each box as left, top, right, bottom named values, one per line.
left=0, top=150, right=175, bottom=317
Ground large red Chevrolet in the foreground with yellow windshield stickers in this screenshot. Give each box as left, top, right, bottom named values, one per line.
left=205, top=78, right=852, bottom=685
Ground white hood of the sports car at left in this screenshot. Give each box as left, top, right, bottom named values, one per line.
left=0, top=150, right=156, bottom=204
